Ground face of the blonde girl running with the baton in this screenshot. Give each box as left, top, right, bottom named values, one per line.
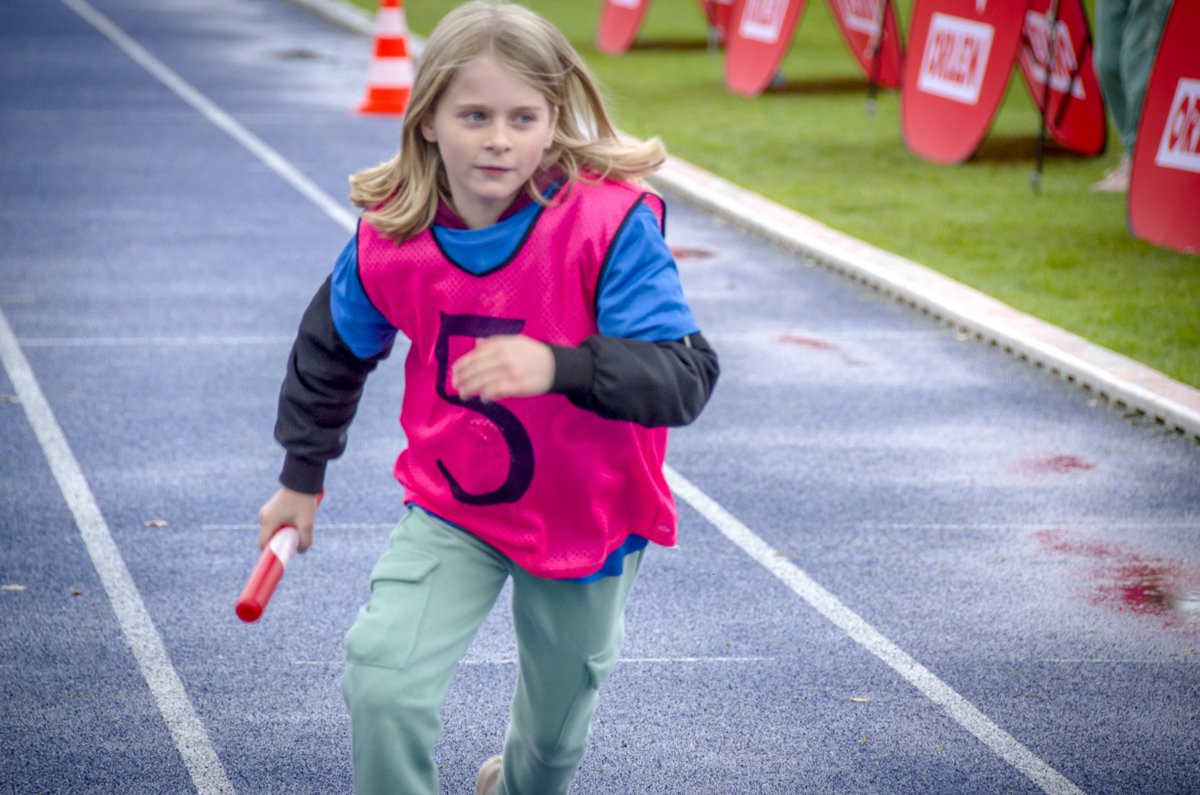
left=421, top=55, right=557, bottom=229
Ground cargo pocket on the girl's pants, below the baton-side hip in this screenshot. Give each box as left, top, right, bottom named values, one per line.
left=346, top=550, right=439, bottom=668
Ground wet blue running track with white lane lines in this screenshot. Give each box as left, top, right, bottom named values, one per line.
left=0, top=0, right=1200, bottom=795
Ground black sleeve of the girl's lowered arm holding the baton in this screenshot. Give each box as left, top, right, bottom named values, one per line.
left=275, top=279, right=391, bottom=494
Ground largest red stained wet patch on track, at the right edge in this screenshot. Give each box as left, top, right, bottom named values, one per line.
left=1033, top=530, right=1200, bottom=630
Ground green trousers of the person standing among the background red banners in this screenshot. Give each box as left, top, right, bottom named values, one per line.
left=1094, top=0, right=1171, bottom=155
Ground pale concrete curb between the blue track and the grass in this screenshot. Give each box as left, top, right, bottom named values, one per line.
left=289, top=0, right=1200, bottom=442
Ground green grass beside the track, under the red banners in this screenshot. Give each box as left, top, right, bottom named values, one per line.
left=355, top=0, right=1200, bottom=387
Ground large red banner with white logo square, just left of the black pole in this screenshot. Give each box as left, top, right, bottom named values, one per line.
left=900, top=0, right=1027, bottom=163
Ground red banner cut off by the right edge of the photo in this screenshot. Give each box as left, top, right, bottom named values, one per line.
left=1129, top=2, right=1200, bottom=253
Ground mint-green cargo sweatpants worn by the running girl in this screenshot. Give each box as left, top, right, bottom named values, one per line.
left=342, top=509, right=642, bottom=795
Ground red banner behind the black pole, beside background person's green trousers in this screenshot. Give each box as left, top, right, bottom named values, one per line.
left=1020, top=0, right=1109, bottom=156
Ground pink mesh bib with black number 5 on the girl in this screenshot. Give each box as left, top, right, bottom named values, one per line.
left=359, top=181, right=677, bottom=578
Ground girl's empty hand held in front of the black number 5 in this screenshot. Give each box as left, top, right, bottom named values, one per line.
left=450, top=335, right=554, bottom=401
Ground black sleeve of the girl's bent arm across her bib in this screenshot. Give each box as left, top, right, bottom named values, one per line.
left=551, top=334, right=720, bottom=428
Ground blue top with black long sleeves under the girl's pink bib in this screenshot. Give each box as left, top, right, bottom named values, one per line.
left=276, top=195, right=719, bottom=494
